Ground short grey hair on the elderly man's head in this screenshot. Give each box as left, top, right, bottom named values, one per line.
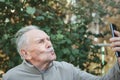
left=15, top=25, right=40, bottom=59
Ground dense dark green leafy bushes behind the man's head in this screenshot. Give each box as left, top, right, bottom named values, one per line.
left=0, top=0, right=119, bottom=75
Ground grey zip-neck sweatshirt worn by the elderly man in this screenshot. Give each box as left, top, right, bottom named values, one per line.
left=2, top=61, right=120, bottom=80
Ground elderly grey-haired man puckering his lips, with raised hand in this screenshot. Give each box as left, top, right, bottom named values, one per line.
left=3, top=25, right=120, bottom=80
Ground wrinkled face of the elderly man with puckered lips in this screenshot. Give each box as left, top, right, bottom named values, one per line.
left=22, top=29, right=56, bottom=64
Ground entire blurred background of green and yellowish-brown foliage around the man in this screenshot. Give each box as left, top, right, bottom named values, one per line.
left=0, top=0, right=120, bottom=77
